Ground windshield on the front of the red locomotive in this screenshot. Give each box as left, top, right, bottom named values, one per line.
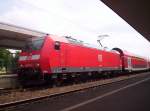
left=25, top=38, right=44, bottom=51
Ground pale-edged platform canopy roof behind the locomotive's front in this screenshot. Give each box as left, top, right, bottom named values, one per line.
left=0, top=22, right=46, bottom=49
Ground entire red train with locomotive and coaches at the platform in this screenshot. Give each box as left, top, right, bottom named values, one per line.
left=18, top=35, right=150, bottom=83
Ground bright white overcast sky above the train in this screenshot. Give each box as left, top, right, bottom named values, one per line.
left=0, top=0, right=150, bottom=59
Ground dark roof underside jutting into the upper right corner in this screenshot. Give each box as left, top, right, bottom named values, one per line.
left=101, top=0, right=150, bottom=41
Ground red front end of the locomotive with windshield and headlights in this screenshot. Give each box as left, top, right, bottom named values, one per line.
left=18, top=37, right=45, bottom=84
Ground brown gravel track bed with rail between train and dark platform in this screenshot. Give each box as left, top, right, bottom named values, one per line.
left=0, top=72, right=150, bottom=111
